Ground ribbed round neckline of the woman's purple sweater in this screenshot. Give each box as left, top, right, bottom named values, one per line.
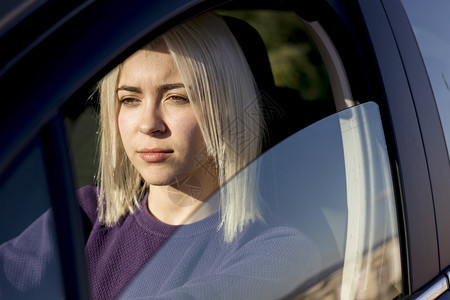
left=134, top=191, right=220, bottom=238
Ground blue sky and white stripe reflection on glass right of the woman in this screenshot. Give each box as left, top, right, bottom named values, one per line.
left=258, top=103, right=401, bottom=299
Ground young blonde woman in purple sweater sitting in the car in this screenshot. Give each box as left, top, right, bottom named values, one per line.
left=0, top=13, right=318, bottom=299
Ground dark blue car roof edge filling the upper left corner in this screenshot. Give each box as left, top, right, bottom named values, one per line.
left=0, top=0, right=203, bottom=173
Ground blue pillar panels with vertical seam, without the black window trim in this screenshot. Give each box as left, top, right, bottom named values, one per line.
left=358, top=0, right=450, bottom=293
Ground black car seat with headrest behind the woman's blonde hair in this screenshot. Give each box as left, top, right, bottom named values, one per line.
left=223, top=16, right=335, bottom=151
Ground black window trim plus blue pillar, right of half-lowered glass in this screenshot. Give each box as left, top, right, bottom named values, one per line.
left=300, top=0, right=450, bottom=296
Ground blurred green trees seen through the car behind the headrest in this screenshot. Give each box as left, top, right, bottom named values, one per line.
left=218, top=10, right=332, bottom=100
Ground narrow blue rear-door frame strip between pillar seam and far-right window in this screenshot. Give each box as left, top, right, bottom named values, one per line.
left=383, top=0, right=450, bottom=271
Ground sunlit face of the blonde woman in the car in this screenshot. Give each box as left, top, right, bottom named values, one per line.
left=117, top=48, right=205, bottom=186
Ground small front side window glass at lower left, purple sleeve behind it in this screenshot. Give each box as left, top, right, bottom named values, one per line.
left=0, top=139, right=64, bottom=299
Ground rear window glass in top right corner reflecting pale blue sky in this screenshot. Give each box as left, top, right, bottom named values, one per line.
left=402, top=0, right=450, bottom=158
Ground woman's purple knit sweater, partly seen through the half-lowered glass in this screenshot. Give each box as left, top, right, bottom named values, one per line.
left=0, top=186, right=320, bottom=299
